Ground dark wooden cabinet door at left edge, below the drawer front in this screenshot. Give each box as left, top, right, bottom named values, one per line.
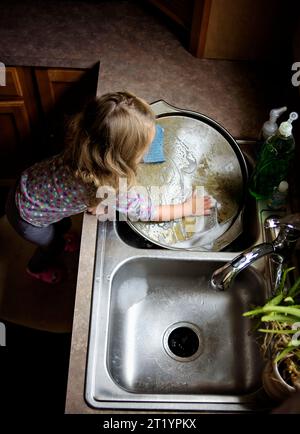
left=0, top=100, right=30, bottom=182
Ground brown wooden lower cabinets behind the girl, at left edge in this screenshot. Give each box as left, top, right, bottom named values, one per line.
left=0, top=63, right=99, bottom=214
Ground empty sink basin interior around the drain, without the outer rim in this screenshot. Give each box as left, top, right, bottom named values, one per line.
left=106, top=257, right=265, bottom=395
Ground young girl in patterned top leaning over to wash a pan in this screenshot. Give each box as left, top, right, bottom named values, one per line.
left=6, top=92, right=211, bottom=283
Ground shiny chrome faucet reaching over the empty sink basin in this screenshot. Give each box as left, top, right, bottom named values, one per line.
left=211, top=213, right=300, bottom=291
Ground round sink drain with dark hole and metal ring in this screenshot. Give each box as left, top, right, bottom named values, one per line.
left=163, top=322, right=202, bottom=362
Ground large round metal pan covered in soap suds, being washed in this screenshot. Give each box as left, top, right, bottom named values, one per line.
left=129, top=101, right=248, bottom=251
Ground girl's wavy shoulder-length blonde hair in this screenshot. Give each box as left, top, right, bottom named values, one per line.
left=62, top=92, right=155, bottom=205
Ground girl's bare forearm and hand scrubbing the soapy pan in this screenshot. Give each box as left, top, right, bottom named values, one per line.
left=152, top=193, right=212, bottom=221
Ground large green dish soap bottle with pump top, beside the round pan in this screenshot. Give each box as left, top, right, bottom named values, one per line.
left=249, top=112, right=298, bottom=199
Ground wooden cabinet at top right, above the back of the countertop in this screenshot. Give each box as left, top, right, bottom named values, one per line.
left=147, top=0, right=300, bottom=60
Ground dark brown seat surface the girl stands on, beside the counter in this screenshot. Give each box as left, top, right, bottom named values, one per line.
left=0, top=216, right=82, bottom=333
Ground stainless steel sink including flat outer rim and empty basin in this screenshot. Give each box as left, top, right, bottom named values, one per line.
left=86, top=200, right=271, bottom=412
